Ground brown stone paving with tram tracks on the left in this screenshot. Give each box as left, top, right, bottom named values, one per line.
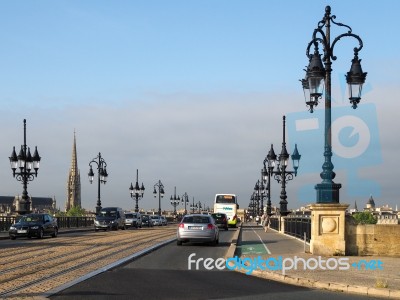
left=0, top=226, right=176, bottom=299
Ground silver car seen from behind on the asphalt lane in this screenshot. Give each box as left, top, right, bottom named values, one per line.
left=176, top=214, right=219, bottom=246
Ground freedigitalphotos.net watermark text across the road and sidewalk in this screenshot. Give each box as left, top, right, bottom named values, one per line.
left=188, top=253, right=383, bottom=275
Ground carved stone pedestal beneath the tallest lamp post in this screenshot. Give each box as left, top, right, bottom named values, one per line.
left=310, top=203, right=349, bottom=256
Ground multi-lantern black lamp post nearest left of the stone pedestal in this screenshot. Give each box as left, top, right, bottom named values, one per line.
left=269, top=116, right=301, bottom=216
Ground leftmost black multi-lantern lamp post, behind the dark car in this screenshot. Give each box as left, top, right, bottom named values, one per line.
left=9, top=119, right=41, bottom=215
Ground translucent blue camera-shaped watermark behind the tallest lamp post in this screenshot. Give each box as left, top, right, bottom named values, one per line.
left=287, top=104, right=382, bottom=202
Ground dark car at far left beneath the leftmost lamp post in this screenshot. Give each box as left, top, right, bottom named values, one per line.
left=8, top=214, right=58, bottom=240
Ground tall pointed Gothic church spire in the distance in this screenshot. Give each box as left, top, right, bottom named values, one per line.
left=65, top=132, right=82, bottom=211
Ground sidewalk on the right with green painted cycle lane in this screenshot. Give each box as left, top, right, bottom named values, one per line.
left=235, top=223, right=400, bottom=299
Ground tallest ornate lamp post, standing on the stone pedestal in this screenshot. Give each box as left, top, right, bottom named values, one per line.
left=301, top=6, right=367, bottom=203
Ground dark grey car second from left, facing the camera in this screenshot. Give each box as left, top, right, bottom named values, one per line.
left=94, top=207, right=126, bottom=231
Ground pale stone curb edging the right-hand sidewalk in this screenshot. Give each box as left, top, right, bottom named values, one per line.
left=233, top=226, right=400, bottom=299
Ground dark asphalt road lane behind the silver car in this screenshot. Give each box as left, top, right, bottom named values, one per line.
left=49, top=229, right=376, bottom=300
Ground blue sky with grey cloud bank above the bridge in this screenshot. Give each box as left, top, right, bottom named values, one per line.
left=0, top=0, right=400, bottom=210
